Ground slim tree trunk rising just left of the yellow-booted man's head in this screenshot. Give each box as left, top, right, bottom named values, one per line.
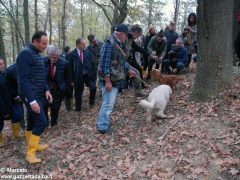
left=23, top=0, right=30, bottom=44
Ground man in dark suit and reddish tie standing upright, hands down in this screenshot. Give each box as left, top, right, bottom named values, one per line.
left=67, top=38, right=96, bottom=111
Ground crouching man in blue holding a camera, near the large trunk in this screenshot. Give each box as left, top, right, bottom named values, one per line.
left=163, top=38, right=187, bottom=74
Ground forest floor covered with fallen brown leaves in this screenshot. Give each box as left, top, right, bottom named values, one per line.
left=0, top=64, right=240, bottom=180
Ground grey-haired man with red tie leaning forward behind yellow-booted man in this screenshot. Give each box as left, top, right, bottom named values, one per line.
left=44, top=46, right=73, bottom=126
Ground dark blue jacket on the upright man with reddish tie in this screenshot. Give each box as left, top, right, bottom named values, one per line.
left=66, top=49, right=96, bottom=87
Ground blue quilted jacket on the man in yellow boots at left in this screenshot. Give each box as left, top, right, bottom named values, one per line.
left=17, top=44, right=48, bottom=103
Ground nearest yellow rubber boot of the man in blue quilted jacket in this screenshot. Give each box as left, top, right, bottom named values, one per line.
left=26, top=134, right=41, bottom=164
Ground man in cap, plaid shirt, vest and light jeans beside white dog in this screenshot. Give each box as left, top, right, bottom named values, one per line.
left=97, top=24, right=136, bottom=134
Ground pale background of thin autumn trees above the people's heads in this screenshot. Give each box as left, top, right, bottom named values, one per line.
left=0, top=0, right=197, bottom=64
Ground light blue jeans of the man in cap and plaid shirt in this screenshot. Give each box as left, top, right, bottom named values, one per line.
left=97, top=86, right=118, bottom=131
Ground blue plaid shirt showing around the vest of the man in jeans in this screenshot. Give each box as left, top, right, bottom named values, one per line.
left=99, top=35, right=129, bottom=89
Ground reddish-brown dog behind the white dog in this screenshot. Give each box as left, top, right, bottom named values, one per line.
left=151, top=69, right=183, bottom=89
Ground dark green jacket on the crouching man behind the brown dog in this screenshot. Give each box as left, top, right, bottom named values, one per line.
left=147, top=36, right=167, bottom=58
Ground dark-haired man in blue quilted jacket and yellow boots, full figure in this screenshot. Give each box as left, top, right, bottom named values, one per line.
left=17, top=31, right=52, bottom=163
